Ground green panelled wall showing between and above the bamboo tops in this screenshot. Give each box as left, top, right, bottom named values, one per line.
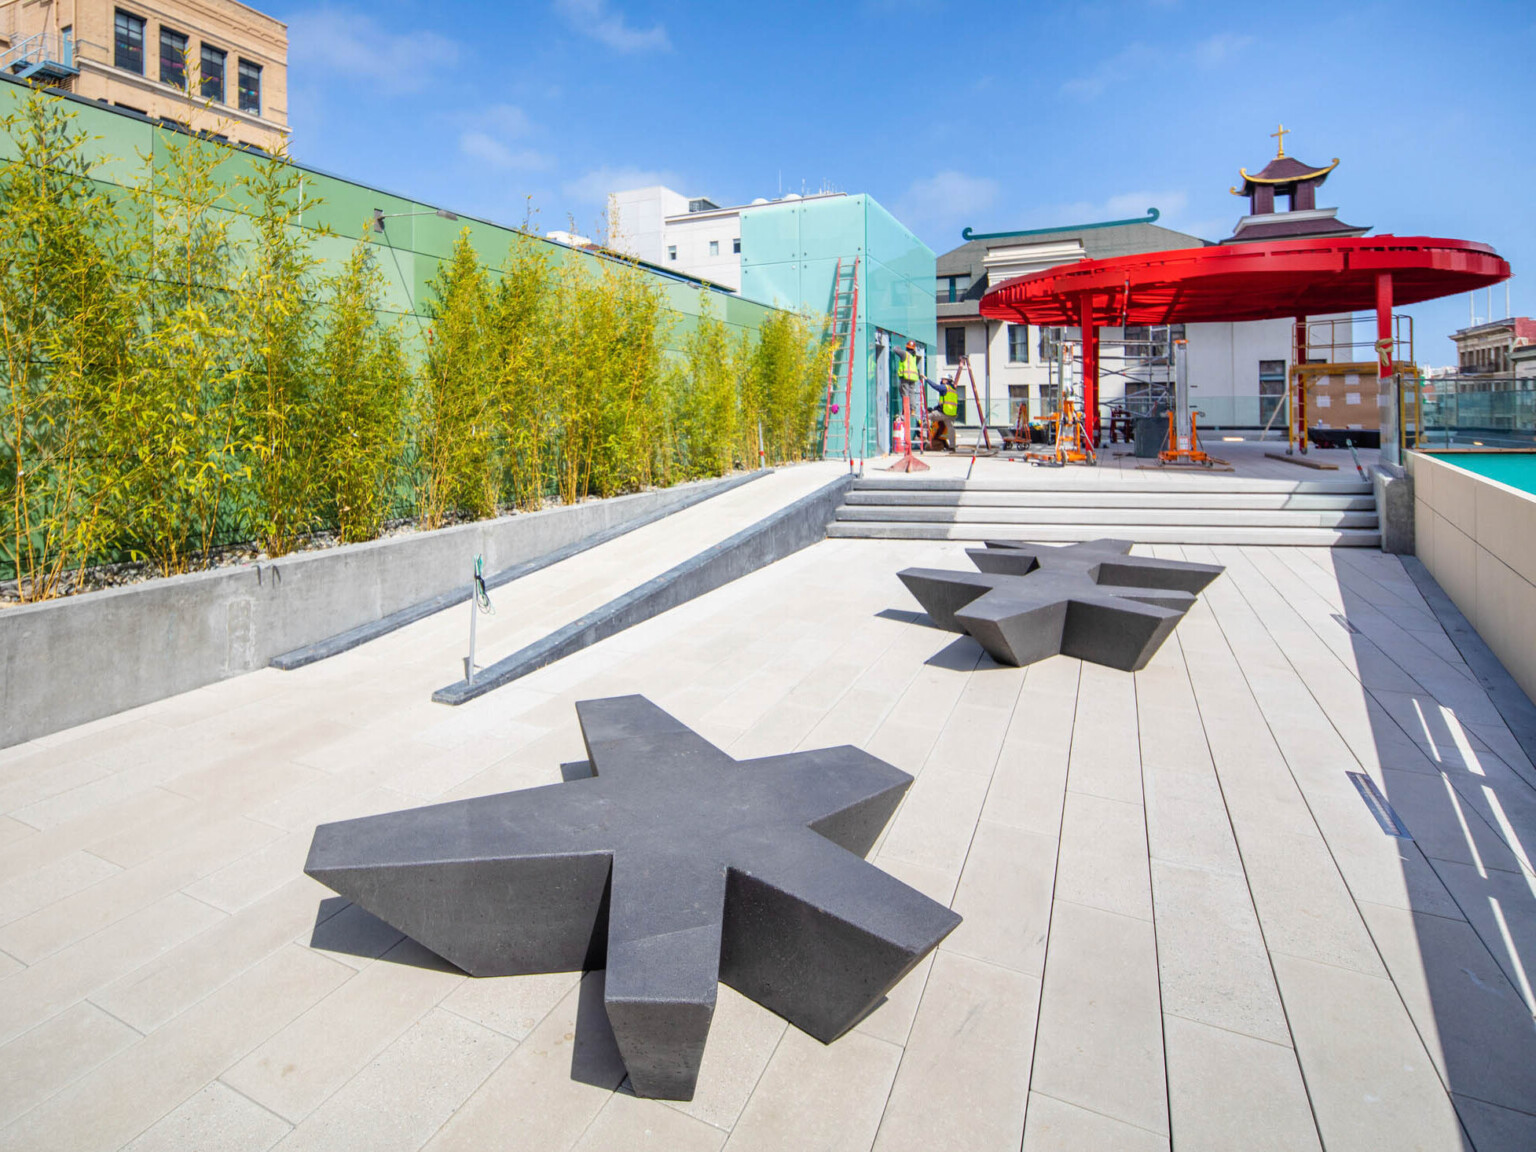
left=0, top=78, right=773, bottom=350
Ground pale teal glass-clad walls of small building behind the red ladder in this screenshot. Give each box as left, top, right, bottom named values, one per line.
left=742, top=195, right=937, bottom=456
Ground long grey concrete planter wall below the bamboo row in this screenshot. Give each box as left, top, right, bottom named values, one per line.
left=0, top=478, right=733, bottom=748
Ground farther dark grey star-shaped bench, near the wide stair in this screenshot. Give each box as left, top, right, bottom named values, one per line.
left=897, top=539, right=1223, bottom=671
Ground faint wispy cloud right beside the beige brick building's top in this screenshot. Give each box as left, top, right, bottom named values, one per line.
left=289, top=5, right=461, bottom=95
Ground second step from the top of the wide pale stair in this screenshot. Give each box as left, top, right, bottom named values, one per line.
left=845, top=488, right=1376, bottom=511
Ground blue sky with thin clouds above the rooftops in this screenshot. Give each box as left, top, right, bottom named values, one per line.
left=270, top=0, right=1536, bottom=364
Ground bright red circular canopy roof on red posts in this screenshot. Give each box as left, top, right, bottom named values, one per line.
left=982, top=237, right=1510, bottom=327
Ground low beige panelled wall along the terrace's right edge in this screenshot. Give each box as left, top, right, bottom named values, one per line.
left=1407, top=452, right=1536, bottom=699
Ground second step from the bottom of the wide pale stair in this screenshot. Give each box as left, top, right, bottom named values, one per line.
left=837, top=505, right=1376, bottom=528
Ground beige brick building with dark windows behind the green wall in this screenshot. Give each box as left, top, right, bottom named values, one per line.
left=0, top=0, right=289, bottom=149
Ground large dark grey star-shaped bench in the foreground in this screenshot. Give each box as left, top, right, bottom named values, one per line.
left=304, top=696, right=960, bottom=1100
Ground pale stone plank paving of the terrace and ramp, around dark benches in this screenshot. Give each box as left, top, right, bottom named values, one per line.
left=0, top=465, right=1536, bottom=1152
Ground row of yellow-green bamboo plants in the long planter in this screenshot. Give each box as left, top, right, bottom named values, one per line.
left=0, top=91, right=828, bottom=599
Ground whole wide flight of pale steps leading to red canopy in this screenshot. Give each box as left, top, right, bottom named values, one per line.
left=826, top=473, right=1381, bottom=548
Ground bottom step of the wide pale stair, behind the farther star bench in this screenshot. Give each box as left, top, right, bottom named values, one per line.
left=826, top=521, right=1381, bottom=548
